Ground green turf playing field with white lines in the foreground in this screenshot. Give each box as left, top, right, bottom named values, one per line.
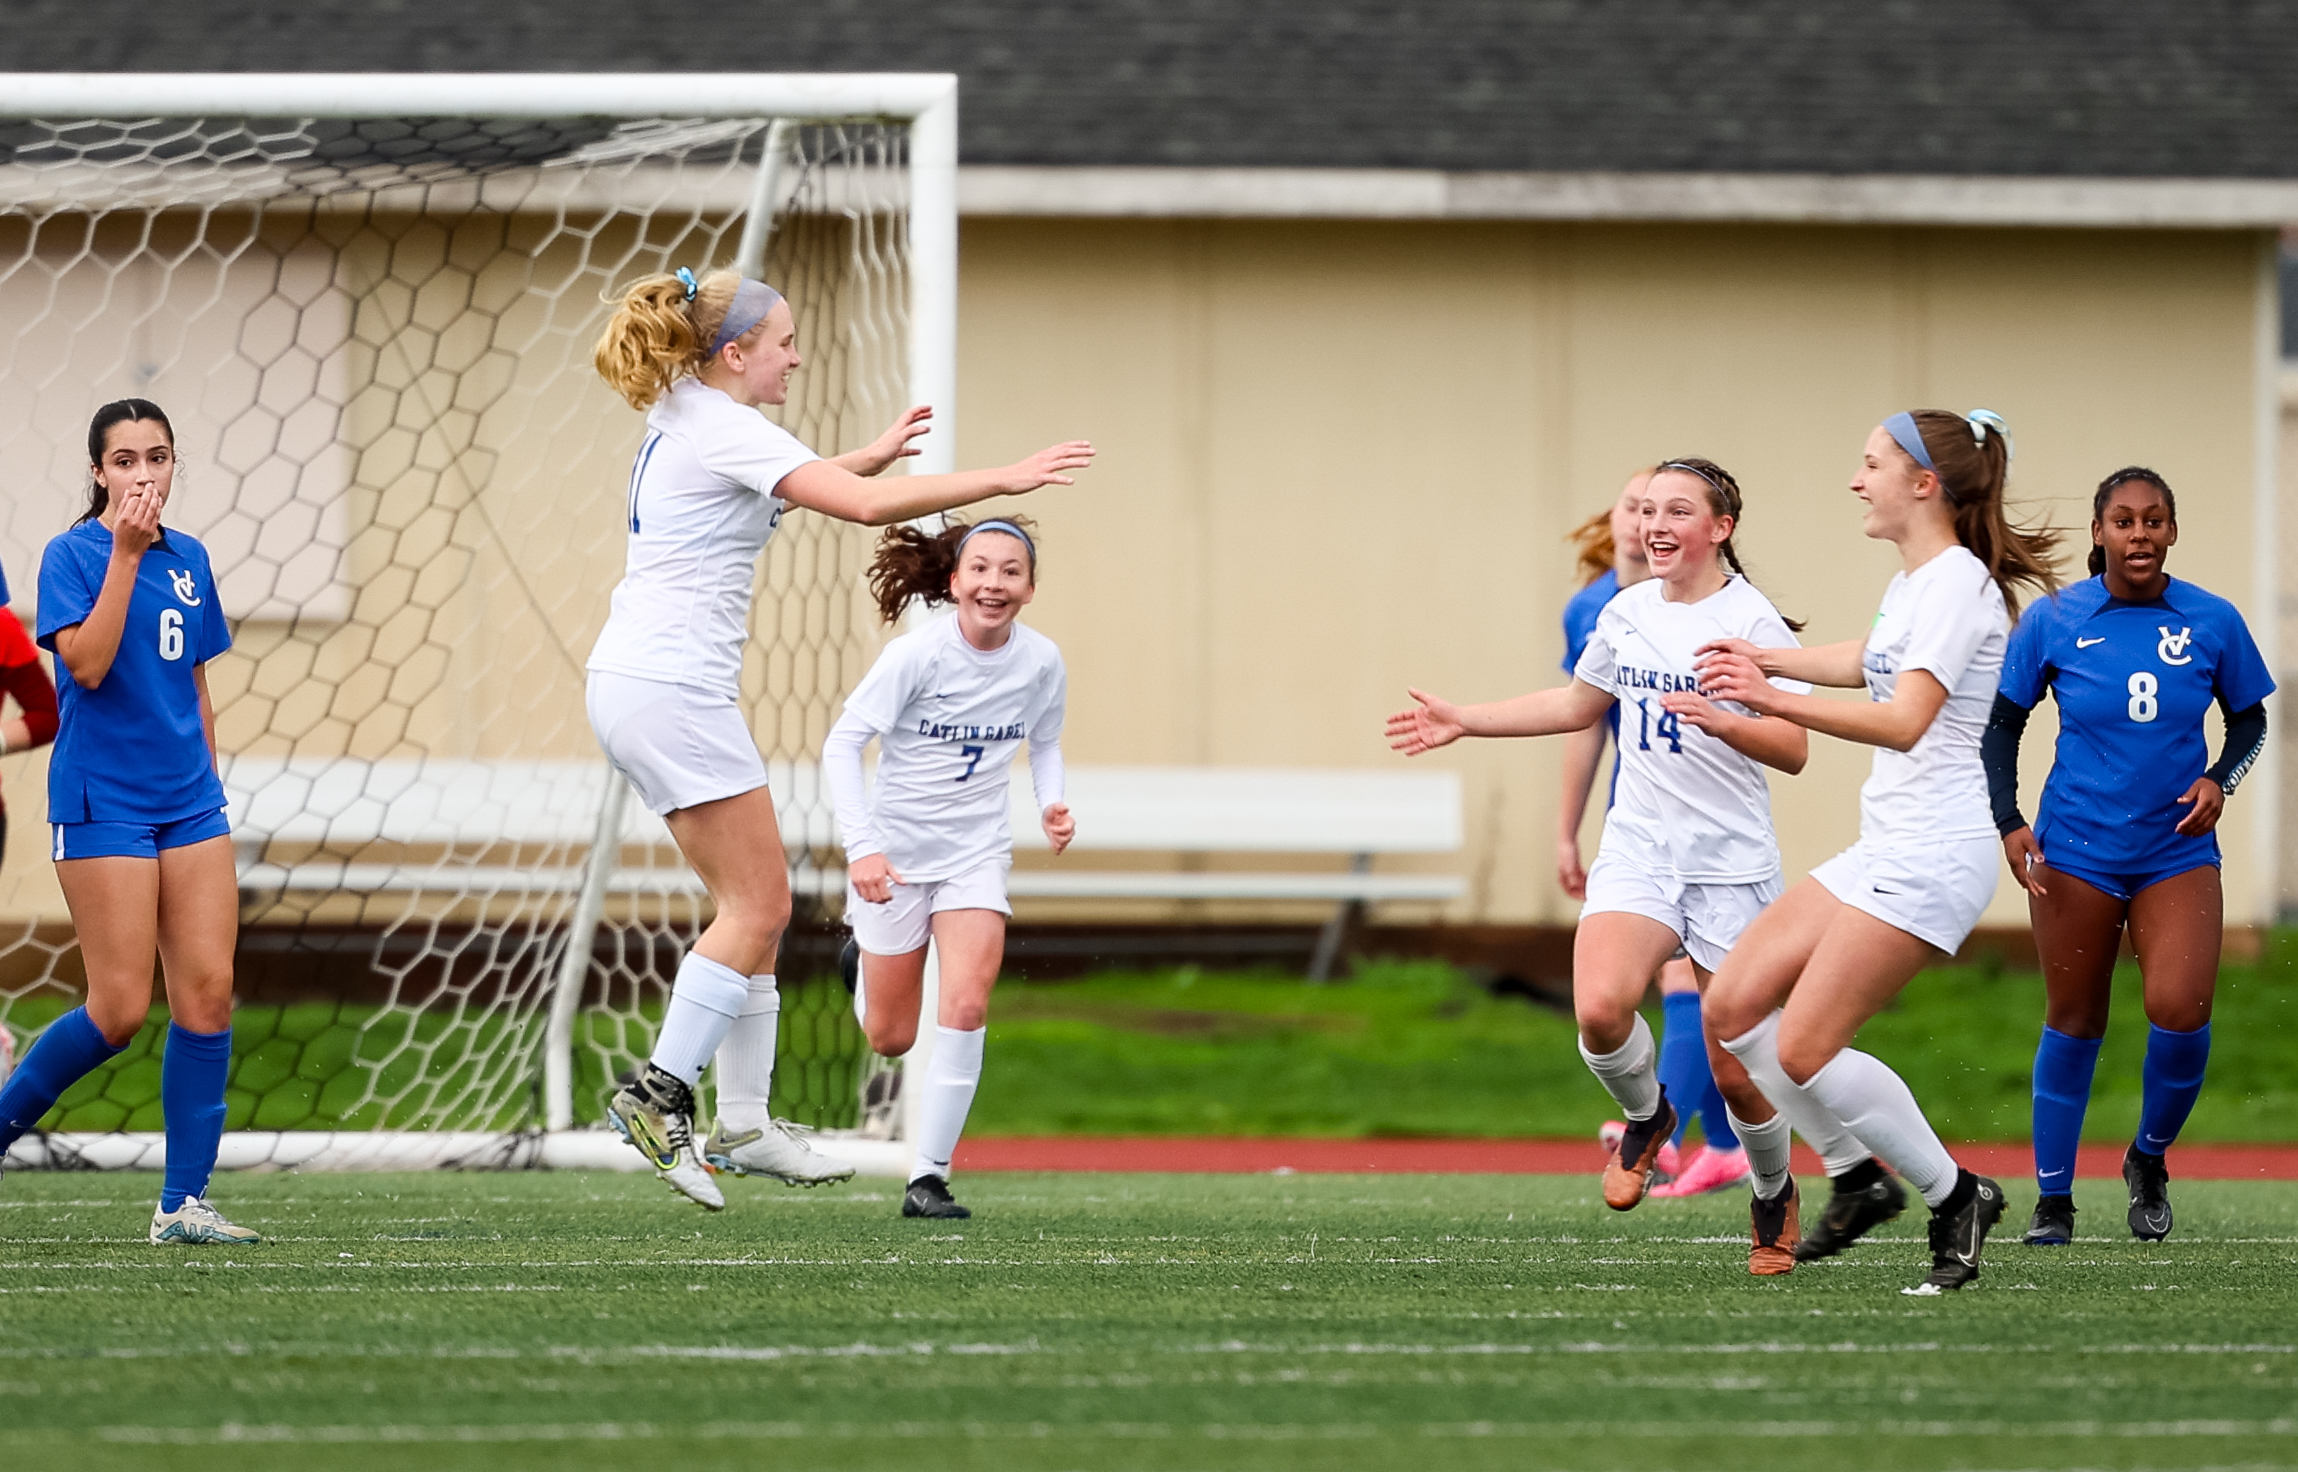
left=0, top=1173, right=2298, bottom=1472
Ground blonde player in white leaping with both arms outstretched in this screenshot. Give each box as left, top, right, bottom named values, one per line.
left=586, top=269, right=1094, bottom=1210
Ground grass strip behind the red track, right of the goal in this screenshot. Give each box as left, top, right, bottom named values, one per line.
left=972, top=932, right=2298, bottom=1141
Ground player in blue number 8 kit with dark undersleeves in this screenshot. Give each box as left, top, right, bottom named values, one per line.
left=1985, top=466, right=2275, bottom=1247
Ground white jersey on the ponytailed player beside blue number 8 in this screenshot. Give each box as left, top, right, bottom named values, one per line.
left=1859, top=547, right=2011, bottom=843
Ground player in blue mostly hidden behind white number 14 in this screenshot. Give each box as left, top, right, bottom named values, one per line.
left=1556, top=468, right=1749, bottom=1196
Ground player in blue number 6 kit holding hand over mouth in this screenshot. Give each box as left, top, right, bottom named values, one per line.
left=0, top=400, right=260, bottom=1245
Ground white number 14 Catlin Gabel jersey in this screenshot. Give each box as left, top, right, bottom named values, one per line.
left=1572, top=576, right=1811, bottom=884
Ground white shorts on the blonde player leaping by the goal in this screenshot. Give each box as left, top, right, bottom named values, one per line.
left=584, top=671, right=765, bottom=815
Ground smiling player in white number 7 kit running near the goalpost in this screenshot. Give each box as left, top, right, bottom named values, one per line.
left=823, top=519, right=1078, bottom=1217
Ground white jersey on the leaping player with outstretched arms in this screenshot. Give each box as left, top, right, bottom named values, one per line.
left=588, top=379, right=818, bottom=696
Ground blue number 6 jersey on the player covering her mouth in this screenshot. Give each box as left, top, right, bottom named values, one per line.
left=39, top=521, right=232, bottom=824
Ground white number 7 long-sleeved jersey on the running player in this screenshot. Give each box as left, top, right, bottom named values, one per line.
left=823, top=613, right=1069, bottom=884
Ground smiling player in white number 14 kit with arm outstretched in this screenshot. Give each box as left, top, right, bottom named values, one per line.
left=1388, top=459, right=1825, bottom=1275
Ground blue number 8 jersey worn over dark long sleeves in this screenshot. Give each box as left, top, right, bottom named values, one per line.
left=1999, top=576, right=2275, bottom=873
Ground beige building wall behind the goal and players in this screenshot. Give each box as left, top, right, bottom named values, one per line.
left=0, top=208, right=2273, bottom=923
